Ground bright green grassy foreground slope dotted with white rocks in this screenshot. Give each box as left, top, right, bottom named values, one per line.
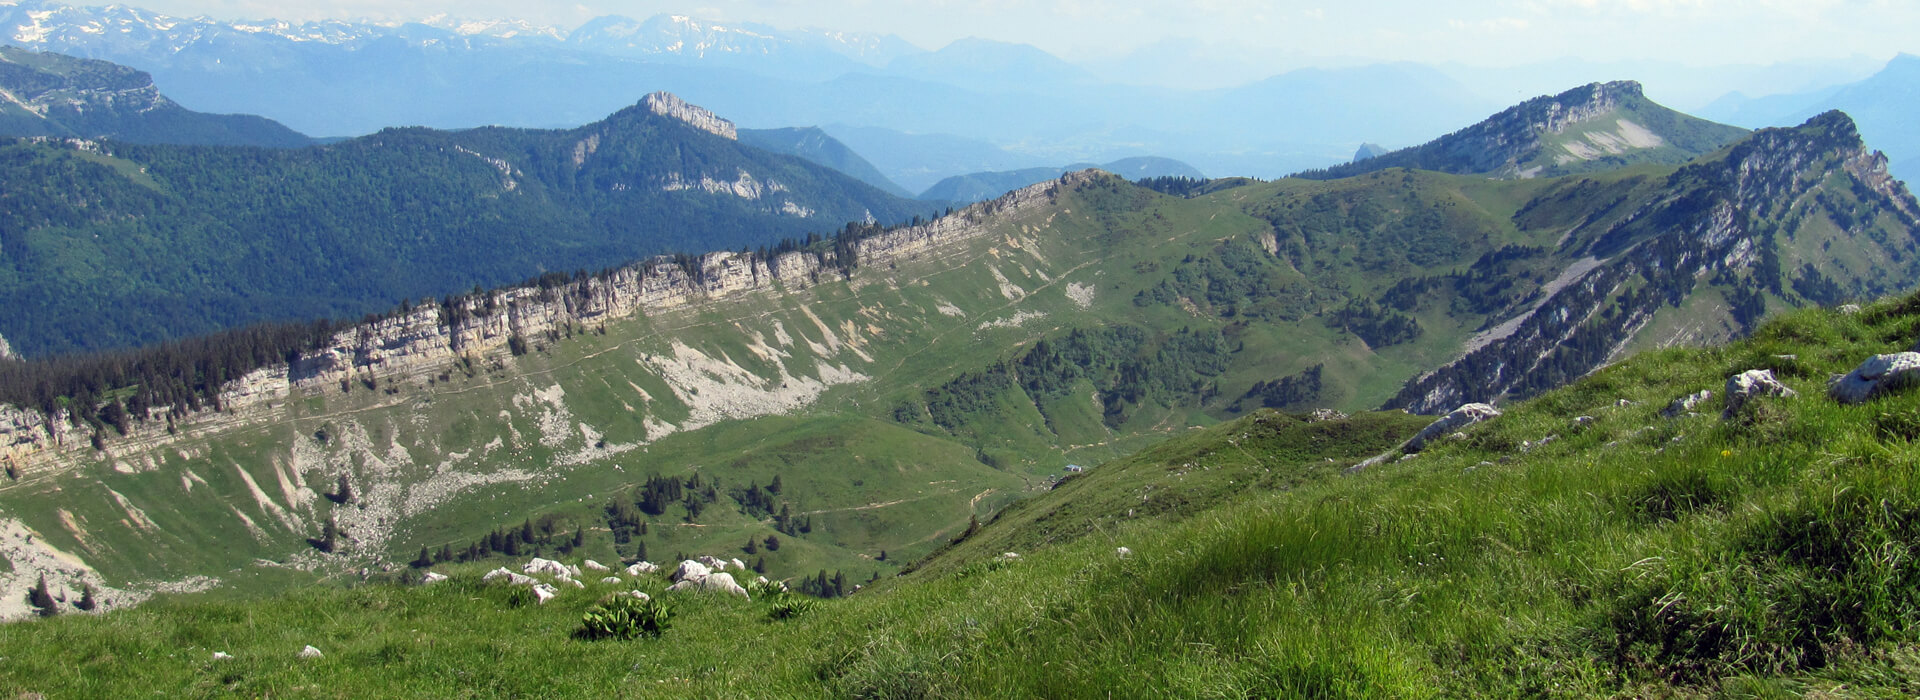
left=0, top=297, right=1920, bottom=698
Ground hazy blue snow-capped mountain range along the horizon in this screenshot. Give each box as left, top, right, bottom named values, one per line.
left=0, top=0, right=1494, bottom=180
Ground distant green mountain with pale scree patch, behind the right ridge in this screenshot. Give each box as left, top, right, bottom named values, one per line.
left=1304, top=81, right=1747, bottom=178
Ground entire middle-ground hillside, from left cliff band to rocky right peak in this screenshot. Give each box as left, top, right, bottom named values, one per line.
left=0, top=92, right=1916, bottom=621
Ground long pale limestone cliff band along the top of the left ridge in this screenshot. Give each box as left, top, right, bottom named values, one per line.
left=0, top=171, right=1082, bottom=474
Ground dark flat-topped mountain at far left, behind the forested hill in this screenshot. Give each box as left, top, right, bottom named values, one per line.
left=0, top=46, right=313, bottom=148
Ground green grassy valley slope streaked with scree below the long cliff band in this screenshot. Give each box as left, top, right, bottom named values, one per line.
left=0, top=140, right=1905, bottom=606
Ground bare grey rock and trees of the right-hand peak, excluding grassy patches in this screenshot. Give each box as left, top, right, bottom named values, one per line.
left=1369, top=109, right=1920, bottom=412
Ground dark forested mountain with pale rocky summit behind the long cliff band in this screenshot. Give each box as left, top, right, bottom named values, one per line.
left=0, top=94, right=933, bottom=357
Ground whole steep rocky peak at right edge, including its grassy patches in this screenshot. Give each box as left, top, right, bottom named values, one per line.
left=1388, top=111, right=1920, bottom=412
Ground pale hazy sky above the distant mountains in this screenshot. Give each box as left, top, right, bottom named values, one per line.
left=116, top=0, right=1920, bottom=65
